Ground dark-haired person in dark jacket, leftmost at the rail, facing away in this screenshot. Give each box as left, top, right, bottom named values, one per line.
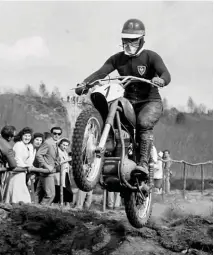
left=0, top=126, right=16, bottom=202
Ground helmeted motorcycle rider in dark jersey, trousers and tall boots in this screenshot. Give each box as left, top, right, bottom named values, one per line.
left=75, top=19, right=171, bottom=177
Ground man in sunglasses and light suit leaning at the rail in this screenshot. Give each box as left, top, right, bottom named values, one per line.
left=36, top=127, right=62, bottom=205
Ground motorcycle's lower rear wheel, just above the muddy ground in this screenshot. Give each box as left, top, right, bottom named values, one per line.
left=124, top=187, right=153, bottom=228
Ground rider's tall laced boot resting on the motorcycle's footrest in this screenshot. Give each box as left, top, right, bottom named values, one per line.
left=136, top=134, right=152, bottom=175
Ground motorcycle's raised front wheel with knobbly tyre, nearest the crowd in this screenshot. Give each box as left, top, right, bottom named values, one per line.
left=72, top=108, right=103, bottom=192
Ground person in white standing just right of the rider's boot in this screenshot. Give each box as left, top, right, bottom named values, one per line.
left=154, top=151, right=163, bottom=194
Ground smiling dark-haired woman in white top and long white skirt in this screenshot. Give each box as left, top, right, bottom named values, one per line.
left=5, top=127, right=36, bottom=203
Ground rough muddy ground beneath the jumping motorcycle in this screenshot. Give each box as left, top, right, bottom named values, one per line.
left=0, top=190, right=213, bottom=255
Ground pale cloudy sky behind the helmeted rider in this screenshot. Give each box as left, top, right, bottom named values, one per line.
left=0, top=1, right=213, bottom=108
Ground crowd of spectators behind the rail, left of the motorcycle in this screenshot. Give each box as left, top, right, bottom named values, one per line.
left=0, top=126, right=92, bottom=209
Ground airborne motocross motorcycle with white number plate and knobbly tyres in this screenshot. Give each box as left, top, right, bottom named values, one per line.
left=72, top=76, right=159, bottom=228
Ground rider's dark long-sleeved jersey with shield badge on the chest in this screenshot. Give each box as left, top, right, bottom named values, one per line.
left=84, top=50, right=171, bottom=102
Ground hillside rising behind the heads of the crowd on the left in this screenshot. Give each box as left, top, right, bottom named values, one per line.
left=0, top=93, right=70, bottom=137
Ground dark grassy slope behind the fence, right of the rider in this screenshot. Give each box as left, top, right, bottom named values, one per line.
left=155, top=114, right=213, bottom=178
